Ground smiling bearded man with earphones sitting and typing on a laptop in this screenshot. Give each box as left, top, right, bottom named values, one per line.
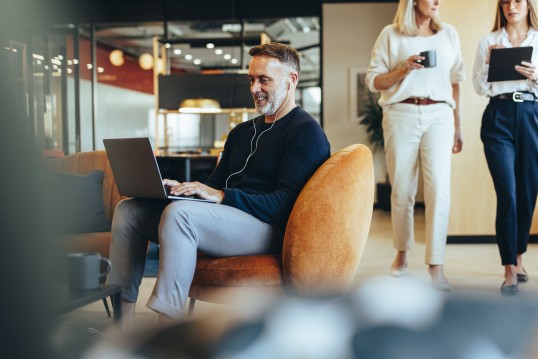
left=108, top=43, right=330, bottom=325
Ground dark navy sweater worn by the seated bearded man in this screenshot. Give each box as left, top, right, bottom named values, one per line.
left=206, top=107, right=331, bottom=233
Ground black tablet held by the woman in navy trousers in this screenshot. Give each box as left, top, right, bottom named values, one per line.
left=488, top=46, right=532, bottom=82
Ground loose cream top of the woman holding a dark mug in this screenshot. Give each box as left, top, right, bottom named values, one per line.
left=366, top=23, right=465, bottom=109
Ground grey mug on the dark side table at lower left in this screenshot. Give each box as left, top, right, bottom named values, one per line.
left=67, top=252, right=112, bottom=290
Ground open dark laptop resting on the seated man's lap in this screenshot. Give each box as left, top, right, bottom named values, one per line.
left=103, top=138, right=215, bottom=203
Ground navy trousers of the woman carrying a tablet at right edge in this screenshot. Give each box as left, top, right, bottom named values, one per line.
left=480, top=99, right=538, bottom=265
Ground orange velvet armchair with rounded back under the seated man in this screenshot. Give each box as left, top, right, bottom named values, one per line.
left=189, top=144, right=374, bottom=312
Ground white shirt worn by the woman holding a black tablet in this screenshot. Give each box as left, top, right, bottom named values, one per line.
left=473, top=27, right=538, bottom=97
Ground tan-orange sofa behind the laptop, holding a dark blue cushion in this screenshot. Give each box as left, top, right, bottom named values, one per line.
left=44, top=151, right=123, bottom=258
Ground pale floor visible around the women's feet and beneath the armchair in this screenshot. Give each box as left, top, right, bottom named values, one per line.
left=68, top=209, right=538, bottom=358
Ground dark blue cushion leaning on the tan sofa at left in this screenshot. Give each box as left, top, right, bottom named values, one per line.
left=54, top=171, right=110, bottom=233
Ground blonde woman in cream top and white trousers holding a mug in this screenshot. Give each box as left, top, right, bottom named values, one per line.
left=366, top=0, right=464, bottom=291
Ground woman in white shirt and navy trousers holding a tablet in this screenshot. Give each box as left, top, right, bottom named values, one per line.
left=473, top=0, right=538, bottom=295
